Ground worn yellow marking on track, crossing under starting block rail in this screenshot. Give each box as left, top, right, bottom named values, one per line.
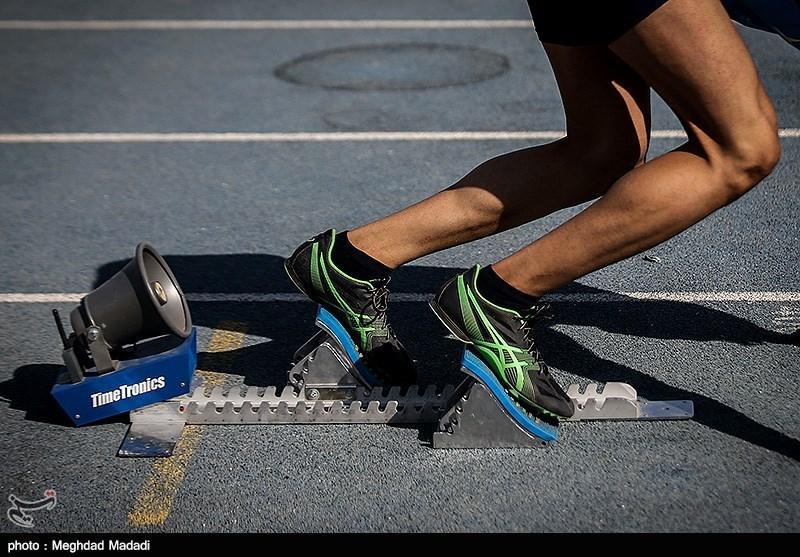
left=128, top=321, right=246, bottom=527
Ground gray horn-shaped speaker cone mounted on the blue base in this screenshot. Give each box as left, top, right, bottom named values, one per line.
left=70, top=243, right=192, bottom=347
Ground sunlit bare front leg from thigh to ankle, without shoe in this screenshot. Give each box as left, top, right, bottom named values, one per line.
left=494, top=0, right=780, bottom=295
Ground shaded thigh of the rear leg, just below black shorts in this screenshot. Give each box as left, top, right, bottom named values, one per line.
left=544, top=43, right=650, bottom=158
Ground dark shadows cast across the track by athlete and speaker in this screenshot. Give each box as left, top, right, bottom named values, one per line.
left=0, top=254, right=800, bottom=461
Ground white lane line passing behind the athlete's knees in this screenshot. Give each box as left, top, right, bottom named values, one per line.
left=0, top=128, right=800, bottom=143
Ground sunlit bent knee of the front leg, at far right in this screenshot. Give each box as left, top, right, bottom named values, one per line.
left=718, top=119, right=781, bottom=201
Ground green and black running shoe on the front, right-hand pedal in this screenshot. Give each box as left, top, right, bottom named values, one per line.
left=431, top=265, right=575, bottom=417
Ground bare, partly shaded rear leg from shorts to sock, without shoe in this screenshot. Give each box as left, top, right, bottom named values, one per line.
left=348, top=45, right=650, bottom=268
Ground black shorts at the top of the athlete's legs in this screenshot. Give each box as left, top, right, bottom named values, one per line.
left=528, top=0, right=667, bottom=46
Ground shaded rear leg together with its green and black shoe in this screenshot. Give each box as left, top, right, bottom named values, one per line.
left=285, top=46, right=649, bottom=385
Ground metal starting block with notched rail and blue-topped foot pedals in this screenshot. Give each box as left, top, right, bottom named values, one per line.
left=118, top=308, right=694, bottom=457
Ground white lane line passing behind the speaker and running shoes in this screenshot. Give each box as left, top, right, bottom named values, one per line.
left=0, top=291, right=800, bottom=304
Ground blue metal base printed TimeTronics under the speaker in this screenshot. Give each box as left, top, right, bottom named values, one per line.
left=51, top=328, right=197, bottom=426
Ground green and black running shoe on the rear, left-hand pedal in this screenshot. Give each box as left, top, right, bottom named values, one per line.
left=284, top=229, right=416, bottom=385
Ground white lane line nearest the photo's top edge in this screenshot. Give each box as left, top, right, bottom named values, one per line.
left=0, top=19, right=533, bottom=31
